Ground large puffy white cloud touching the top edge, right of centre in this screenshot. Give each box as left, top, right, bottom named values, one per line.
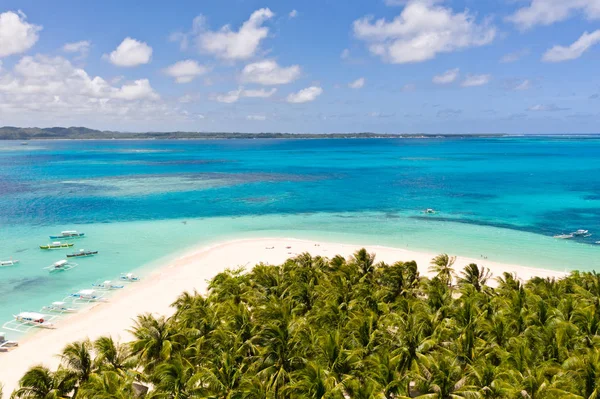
left=354, top=0, right=496, bottom=64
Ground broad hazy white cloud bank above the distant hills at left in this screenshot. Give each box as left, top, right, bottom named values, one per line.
left=0, top=55, right=171, bottom=124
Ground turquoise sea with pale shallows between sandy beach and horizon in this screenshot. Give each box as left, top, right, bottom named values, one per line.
left=0, top=137, right=600, bottom=340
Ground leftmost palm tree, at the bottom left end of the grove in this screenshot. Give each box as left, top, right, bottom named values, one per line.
left=11, top=366, right=77, bottom=399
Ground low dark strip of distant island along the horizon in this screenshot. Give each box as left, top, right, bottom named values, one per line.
left=0, top=126, right=504, bottom=140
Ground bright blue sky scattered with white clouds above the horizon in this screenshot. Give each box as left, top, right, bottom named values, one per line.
left=0, top=0, right=600, bottom=133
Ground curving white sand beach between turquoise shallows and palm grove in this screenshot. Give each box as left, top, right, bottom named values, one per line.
left=0, top=238, right=564, bottom=394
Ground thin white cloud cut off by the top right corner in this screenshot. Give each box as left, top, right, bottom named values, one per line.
left=507, top=0, right=600, bottom=30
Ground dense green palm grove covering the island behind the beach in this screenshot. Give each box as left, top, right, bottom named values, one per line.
left=7, top=249, right=600, bottom=399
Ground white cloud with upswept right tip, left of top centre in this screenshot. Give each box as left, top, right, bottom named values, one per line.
left=192, top=8, right=275, bottom=60
